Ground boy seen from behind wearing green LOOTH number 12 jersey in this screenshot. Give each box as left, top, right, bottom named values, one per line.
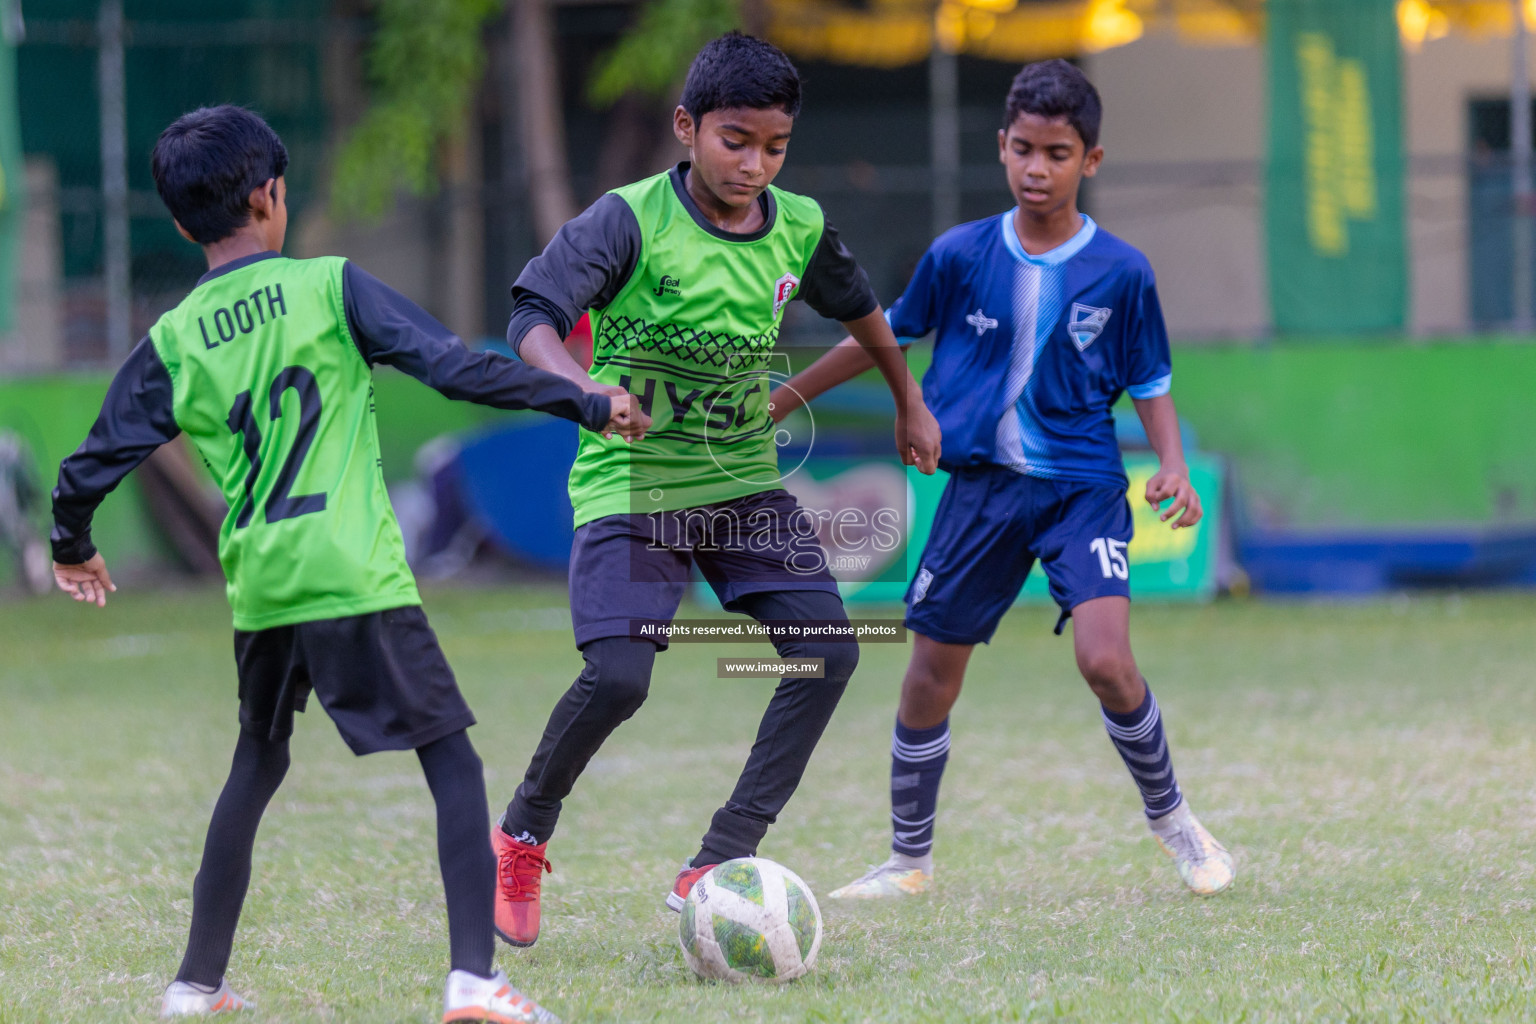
left=52, top=106, right=645, bottom=1021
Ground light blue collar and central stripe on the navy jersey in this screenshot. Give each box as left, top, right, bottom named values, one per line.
left=995, top=210, right=1098, bottom=477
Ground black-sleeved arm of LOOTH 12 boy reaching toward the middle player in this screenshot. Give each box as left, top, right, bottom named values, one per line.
left=343, top=263, right=645, bottom=436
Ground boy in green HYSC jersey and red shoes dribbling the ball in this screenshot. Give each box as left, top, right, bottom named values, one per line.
left=492, top=32, right=938, bottom=946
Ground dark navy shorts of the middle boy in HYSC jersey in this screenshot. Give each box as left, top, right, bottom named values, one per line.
left=570, top=488, right=837, bottom=648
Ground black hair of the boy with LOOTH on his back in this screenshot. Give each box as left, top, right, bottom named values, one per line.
left=149, top=103, right=287, bottom=246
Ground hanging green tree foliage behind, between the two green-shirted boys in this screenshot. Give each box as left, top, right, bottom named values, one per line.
left=330, top=0, right=497, bottom=220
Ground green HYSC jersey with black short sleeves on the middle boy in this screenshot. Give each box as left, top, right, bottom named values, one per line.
left=568, top=166, right=876, bottom=525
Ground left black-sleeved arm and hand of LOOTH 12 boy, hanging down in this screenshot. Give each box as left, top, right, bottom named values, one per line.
left=51, top=338, right=181, bottom=608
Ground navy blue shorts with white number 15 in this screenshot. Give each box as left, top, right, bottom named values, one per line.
left=906, top=467, right=1132, bottom=643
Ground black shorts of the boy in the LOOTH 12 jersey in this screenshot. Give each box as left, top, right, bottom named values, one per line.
left=235, top=605, right=475, bottom=755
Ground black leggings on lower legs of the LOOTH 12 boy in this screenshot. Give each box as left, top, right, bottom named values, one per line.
left=177, top=729, right=496, bottom=986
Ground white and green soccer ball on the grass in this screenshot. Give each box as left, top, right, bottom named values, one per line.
left=677, top=857, right=822, bottom=983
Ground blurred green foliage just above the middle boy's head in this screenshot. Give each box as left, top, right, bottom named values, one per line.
left=587, top=0, right=745, bottom=106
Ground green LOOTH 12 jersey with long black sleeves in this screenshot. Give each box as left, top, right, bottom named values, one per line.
left=54, top=252, right=610, bottom=631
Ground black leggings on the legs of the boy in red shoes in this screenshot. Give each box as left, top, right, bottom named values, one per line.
left=502, top=591, right=859, bottom=863
